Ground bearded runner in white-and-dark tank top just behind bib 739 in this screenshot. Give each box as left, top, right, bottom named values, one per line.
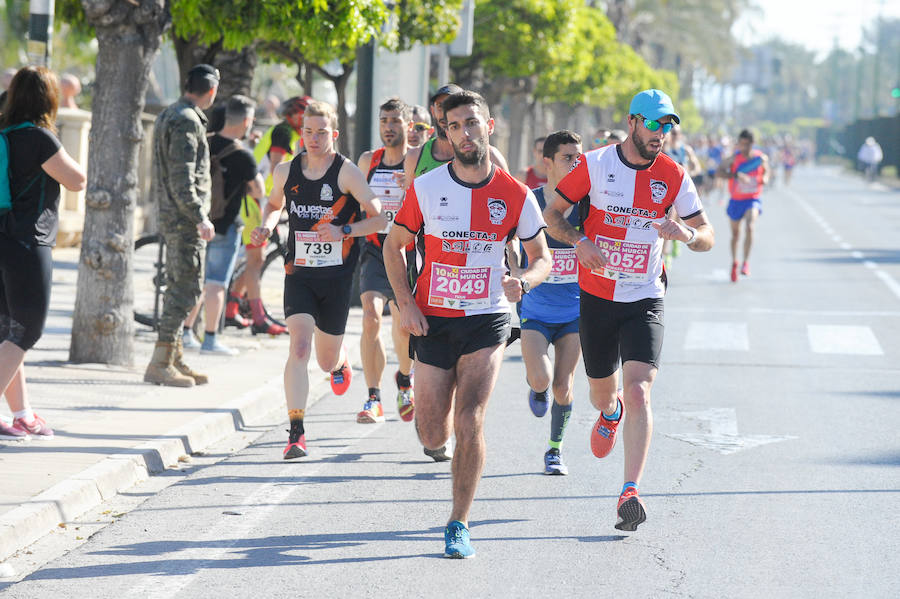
left=356, top=98, right=415, bottom=423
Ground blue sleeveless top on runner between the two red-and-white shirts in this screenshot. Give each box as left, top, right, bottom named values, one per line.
left=520, top=187, right=581, bottom=324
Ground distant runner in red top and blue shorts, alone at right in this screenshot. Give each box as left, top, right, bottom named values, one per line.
left=716, top=129, right=769, bottom=283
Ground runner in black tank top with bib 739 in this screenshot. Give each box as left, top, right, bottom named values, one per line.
left=252, top=102, right=387, bottom=460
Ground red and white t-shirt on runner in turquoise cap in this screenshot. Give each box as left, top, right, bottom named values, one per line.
left=556, top=145, right=703, bottom=302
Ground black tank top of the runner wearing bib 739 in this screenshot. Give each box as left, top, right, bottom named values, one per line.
left=284, top=154, right=360, bottom=278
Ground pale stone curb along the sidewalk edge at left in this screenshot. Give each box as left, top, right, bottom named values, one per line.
left=0, top=350, right=359, bottom=563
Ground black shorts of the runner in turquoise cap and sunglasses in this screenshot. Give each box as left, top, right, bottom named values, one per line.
left=579, top=289, right=665, bottom=379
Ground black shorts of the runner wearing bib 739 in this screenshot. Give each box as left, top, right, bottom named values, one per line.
left=284, top=273, right=353, bottom=335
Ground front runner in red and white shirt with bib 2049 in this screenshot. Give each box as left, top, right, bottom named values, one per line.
left=384, top=91, right=550, bottom=558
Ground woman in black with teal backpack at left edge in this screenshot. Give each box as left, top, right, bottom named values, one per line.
left=0, top=67, right=86, bottom=439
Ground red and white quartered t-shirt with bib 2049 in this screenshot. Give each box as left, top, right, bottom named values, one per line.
left=394, top=164, right=546, bottom=317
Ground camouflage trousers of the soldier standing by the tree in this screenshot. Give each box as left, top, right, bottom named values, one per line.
left=159, top=224, right=206, bottom=343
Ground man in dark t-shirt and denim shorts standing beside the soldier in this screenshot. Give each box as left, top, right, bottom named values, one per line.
left=183, top=95, right=263, bottom=356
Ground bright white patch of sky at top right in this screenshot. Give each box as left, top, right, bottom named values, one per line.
left=732, top=0, right=900, bottom=59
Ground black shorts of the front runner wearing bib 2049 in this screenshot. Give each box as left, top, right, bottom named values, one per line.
left=409, top=313, right=509, bottom=370
